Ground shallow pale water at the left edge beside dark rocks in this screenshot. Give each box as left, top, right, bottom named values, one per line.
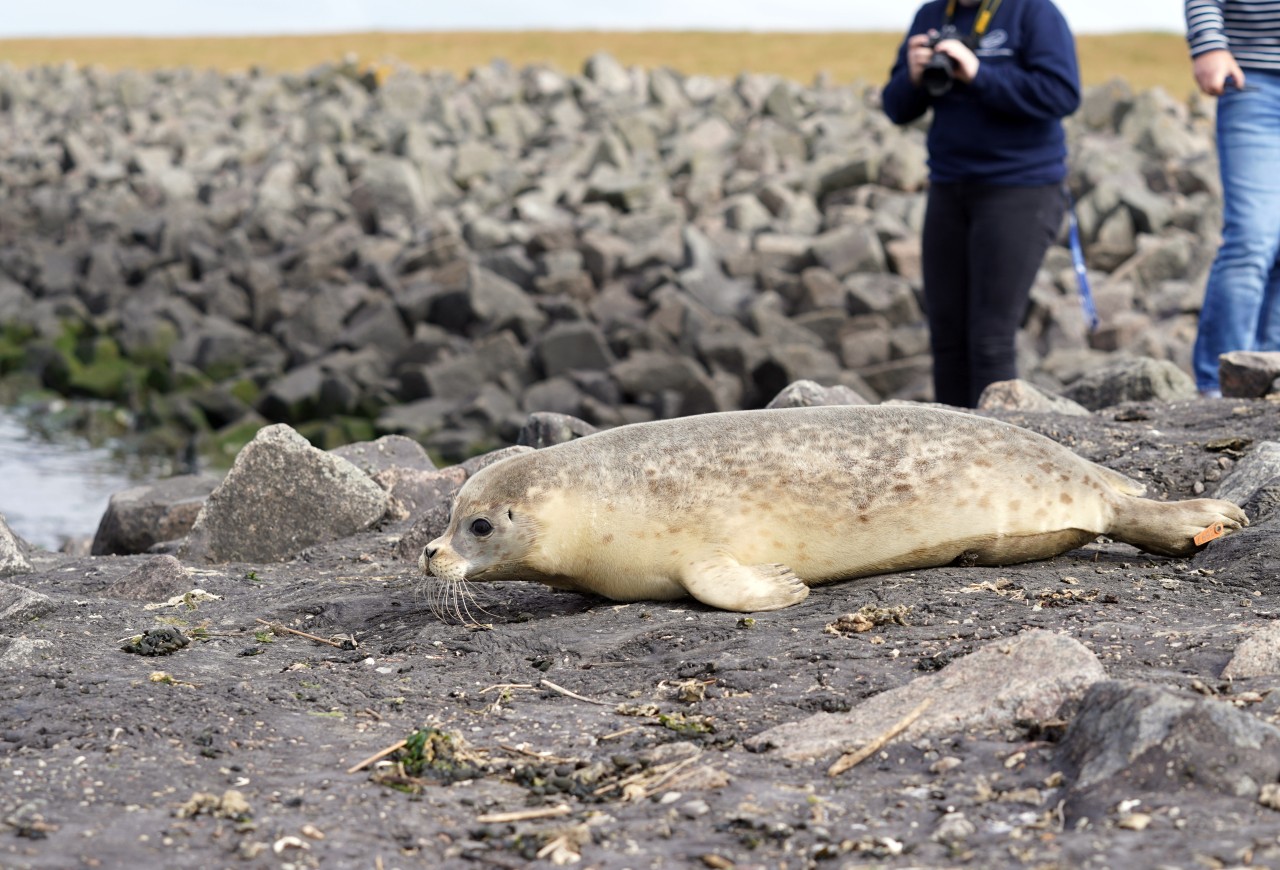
left=0, top=408, right=165, bottom=550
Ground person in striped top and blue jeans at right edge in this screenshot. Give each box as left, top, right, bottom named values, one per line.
left=1185, top=0, right=1280, bottom=397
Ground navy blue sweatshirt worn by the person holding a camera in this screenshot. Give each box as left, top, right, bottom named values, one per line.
left=882, top=0, right=1080, bottom=187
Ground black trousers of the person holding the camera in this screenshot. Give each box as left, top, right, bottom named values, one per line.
left=922, top=182, right=1066, bottom=408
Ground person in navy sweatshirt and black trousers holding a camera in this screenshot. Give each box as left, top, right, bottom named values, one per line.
left=881, top=0, right=1080, bottom=407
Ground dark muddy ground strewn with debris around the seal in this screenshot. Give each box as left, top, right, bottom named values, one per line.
left=0, top=400, right=1280, bottom=869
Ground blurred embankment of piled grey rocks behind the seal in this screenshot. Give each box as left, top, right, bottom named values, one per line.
left=0, top=56, right=1219, bottom=461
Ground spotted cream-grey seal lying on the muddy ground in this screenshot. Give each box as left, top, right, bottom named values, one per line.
left=419, top=406, right=1248, bottom=612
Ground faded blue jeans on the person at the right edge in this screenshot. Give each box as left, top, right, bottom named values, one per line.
left=1193, top=69, right=1280, bottom=390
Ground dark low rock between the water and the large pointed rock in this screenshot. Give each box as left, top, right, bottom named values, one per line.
left=90, top=475, right=221, bottom=555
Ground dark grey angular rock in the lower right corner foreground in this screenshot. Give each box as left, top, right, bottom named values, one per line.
left=1057, top=681, right=1280, bottom=825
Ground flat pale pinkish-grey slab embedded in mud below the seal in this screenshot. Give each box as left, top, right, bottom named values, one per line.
left=746, top=631, right=1106, bottom=761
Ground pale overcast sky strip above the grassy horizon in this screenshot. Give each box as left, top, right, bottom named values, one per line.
left=0, top=0, right=1183, bottom=38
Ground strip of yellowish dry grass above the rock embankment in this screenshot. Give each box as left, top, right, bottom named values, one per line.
left=0, top=31, right=1193, bottom=97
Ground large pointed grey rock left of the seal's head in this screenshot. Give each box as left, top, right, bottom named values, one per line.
left=178, top=423, right=389, bottom=563
